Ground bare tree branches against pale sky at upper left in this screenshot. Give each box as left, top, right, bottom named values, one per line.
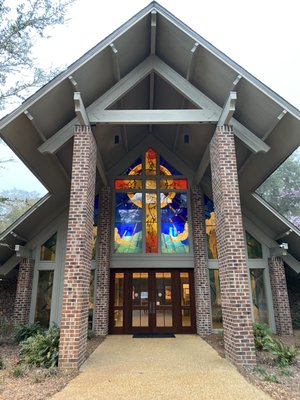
left=0, top=0, right=74, bottom=109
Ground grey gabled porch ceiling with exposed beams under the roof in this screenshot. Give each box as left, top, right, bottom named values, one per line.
left=0, top=2, right=300, bottom=272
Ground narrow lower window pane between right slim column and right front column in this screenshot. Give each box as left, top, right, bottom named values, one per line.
left=209, top=269, right=223, bottom=329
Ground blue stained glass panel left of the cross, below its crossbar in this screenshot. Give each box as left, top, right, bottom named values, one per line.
left=114, top=193, right=142, bottom=253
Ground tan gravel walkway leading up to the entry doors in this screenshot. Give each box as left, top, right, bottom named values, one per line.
left=52, top=335, right=271, bottom=400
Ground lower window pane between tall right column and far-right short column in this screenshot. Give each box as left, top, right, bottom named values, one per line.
left=250, top=269, right=269, bottom=324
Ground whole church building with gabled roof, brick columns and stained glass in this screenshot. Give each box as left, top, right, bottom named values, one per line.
left=0, top=1, right=300, bottom=368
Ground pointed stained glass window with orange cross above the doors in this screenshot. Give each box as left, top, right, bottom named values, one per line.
left=114, top=148, right=189, bottom=254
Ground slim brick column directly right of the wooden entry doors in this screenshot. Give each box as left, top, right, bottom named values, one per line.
left=191, top=186, right=212, bottom=335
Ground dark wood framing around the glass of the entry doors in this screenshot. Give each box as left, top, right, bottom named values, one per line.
left=109, top=268, right=196, bottom=334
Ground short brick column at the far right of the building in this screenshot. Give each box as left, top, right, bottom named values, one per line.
left=268, top=257, right=293, bottom=335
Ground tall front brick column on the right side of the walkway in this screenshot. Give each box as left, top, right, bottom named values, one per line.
left=210, top=126, right=256, bottom=366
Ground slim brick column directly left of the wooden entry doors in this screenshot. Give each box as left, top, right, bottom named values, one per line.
left=94, top=187, right=112, bottom=336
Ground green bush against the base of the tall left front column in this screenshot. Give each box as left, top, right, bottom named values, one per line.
left=20, top=325, right=60, bottom=368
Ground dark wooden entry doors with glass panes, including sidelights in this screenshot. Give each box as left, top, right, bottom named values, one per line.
left=110, top=270, right=195, bottom=334
